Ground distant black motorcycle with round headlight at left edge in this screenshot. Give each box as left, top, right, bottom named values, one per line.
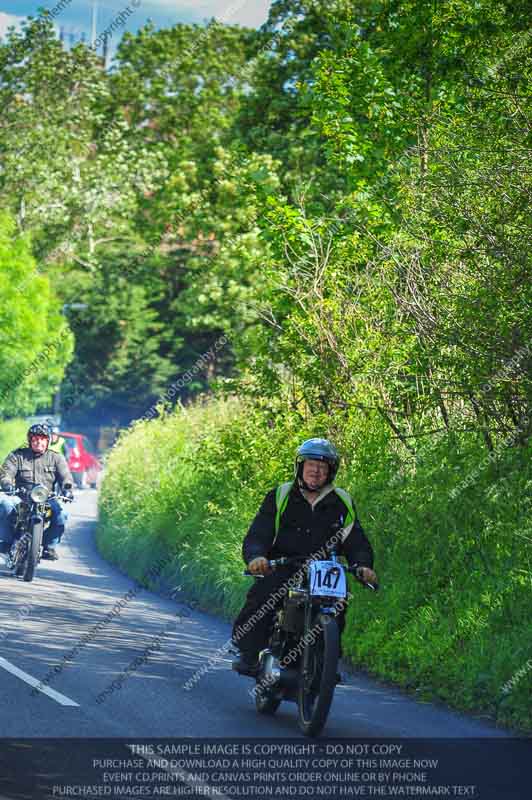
left=6, top=484, right=72, bottom=581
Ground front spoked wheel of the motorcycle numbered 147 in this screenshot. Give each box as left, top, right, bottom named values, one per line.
left=297, top=614, right=340, bottom=736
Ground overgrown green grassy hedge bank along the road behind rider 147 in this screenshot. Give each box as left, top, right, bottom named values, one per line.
left=98, top=400, right=532, bottom=731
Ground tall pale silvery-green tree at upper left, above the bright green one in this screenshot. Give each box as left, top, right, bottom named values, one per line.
left=0, top=17, right=166, bottom=266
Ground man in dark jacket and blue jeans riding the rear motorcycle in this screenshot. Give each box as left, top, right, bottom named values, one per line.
left=0, top=424, right=74, bottom=561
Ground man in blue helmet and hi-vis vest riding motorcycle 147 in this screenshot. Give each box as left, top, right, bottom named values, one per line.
left=232, top=438, right=377, bottom=675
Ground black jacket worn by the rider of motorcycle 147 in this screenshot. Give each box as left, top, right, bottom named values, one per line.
left=242, top=484, right=373, bottom=567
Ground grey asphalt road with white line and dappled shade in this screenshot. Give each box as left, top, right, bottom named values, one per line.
left=0, top=490, right=509, bottom=738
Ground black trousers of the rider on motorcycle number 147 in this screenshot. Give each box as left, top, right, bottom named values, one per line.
left=232, top=568, right=347, bottom=655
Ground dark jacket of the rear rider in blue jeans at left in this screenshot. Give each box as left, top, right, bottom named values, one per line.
left=0, top=447, right=74, bottom=492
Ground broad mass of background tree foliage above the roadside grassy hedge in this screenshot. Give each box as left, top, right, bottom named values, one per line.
left=0, top=0, right=532, bottom=452
